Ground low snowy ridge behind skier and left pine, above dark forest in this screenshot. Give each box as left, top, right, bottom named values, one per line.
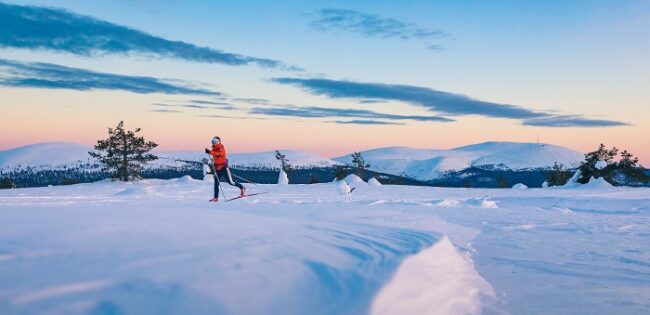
left=0, top=142, right=340, bottom=171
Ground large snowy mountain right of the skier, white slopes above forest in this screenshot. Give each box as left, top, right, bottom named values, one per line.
left=334, top=142, right=584, bottom=180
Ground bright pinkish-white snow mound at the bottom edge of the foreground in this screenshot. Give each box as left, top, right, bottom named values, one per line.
left=370, top=237, right=496, bottom=315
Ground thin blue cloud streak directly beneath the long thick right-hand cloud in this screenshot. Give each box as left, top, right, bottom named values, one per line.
left=249, top=105, right=453, bottom=122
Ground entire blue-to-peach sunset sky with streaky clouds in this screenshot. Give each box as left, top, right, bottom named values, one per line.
left=0, top=0, right=650, bottom=165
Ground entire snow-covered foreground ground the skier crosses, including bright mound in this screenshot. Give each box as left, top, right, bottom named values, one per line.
left=0, top=178, right=650, bottom=314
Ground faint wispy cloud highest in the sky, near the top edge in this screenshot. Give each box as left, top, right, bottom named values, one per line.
left=311, top=9, right=448, bottom=50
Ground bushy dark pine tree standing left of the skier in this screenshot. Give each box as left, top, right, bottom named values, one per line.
left=88, top=121, right=158, bottom=181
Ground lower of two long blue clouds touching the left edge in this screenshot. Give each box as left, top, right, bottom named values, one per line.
left=0, top=59, right=221, bottom=96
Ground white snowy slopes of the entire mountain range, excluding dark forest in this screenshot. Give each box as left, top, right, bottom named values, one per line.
left=0, top=142, right=583, bottom=181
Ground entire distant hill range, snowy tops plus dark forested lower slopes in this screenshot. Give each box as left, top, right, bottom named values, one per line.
left=0, top=142, right=583, bottom=187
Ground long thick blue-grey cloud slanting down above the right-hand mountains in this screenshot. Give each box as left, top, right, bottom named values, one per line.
left=273, top=78, right=627, bottom=127
